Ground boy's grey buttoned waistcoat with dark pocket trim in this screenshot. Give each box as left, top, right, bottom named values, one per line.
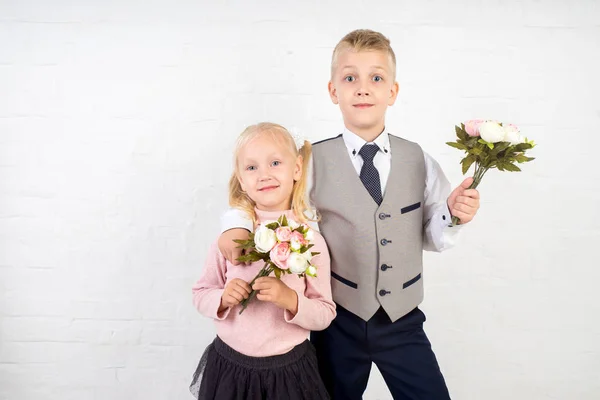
left=311, top=135, right=425, bottom=321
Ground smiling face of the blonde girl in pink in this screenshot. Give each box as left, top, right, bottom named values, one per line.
left=238, top=134, right=302, bottom=211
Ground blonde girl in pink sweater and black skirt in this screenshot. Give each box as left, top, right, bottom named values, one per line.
left=190, top=123, right=336, bottom=400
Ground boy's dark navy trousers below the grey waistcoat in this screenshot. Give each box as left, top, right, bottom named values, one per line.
left=311, top=304, right=450, bottom=400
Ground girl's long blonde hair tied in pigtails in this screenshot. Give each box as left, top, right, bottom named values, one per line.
left=229, top=122, right=316, bottom=223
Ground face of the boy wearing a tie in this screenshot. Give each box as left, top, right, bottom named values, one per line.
left=329, top=50, right=398, bottom=141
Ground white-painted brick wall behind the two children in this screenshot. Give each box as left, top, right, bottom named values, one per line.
left=0, top=0, right=600, bottom=400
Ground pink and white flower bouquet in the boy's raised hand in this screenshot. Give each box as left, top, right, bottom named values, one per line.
left=446, top=119, right=535, bottom=225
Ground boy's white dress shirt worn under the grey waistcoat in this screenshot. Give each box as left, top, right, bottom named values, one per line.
left=221, top=129, right=461, bottom=252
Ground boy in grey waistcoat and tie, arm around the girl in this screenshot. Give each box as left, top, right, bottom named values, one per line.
left=219, top=30, right=479, bottom=400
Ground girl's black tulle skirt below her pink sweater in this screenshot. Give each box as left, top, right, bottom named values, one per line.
left=190, top=337, right=330, bottom=400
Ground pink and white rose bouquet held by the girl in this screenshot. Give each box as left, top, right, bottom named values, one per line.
left=235, top=215, right=319, bottom=314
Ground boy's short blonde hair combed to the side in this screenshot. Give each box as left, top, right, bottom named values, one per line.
left=331, top=29, right=396, bottom=78
